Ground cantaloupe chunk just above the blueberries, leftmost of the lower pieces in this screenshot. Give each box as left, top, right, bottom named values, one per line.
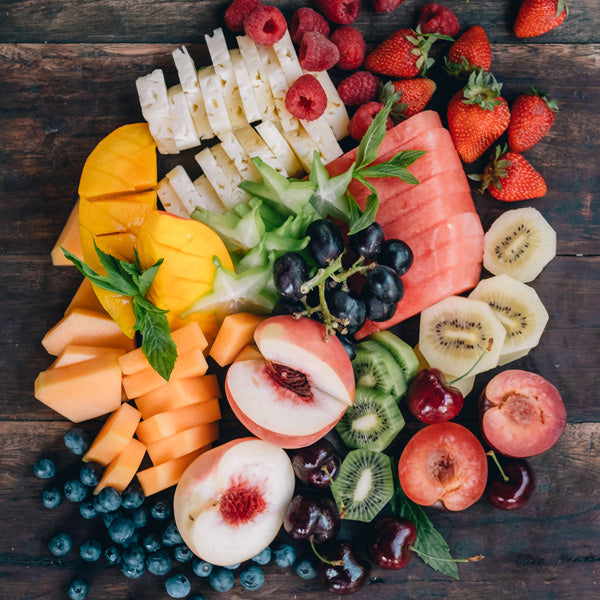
left=82, top=402, right=142, bottom=466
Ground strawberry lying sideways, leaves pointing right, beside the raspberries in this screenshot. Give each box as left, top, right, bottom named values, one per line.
left=365, top=27, right=452, bottom=79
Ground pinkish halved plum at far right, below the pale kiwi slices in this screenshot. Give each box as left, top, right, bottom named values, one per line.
left=479, top=369, right=567, bottom=458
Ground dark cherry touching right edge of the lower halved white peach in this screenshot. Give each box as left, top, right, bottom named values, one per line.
left=283, top=494, right=340, bottom=544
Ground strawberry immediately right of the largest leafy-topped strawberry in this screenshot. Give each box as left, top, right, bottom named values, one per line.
left=508, top=86, right=558, bottom=152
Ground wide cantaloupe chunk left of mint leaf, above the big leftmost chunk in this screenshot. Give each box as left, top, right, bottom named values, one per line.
left=42, top=308, right=134, bottom=356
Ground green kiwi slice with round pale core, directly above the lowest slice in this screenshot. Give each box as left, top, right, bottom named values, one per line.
left=336, top=386, right=404, bottom=451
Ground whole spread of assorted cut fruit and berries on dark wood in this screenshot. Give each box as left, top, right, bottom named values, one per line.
left=34, top=0, right=566, bottom=599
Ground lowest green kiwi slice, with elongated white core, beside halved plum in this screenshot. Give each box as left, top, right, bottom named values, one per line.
left=331, top=449, right=394, bottom=522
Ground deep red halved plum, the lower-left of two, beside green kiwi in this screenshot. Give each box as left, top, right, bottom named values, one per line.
left=398, top=421, right=487, bottom=511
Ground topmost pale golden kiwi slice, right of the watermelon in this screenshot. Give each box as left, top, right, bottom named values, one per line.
left=483, top=207, right=556, bottom=283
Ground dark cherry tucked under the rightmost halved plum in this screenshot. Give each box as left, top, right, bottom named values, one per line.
left=485, top=457, right=535, bottom=510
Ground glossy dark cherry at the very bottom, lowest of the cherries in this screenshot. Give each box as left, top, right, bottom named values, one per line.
left=317, top=540, right=371, bottom=596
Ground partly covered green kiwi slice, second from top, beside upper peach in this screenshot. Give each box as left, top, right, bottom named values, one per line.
left=352, top=340, right=407, bottom=400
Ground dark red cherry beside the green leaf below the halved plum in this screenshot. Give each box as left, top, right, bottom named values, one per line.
left=367, top=517, right=417, bottom=569
